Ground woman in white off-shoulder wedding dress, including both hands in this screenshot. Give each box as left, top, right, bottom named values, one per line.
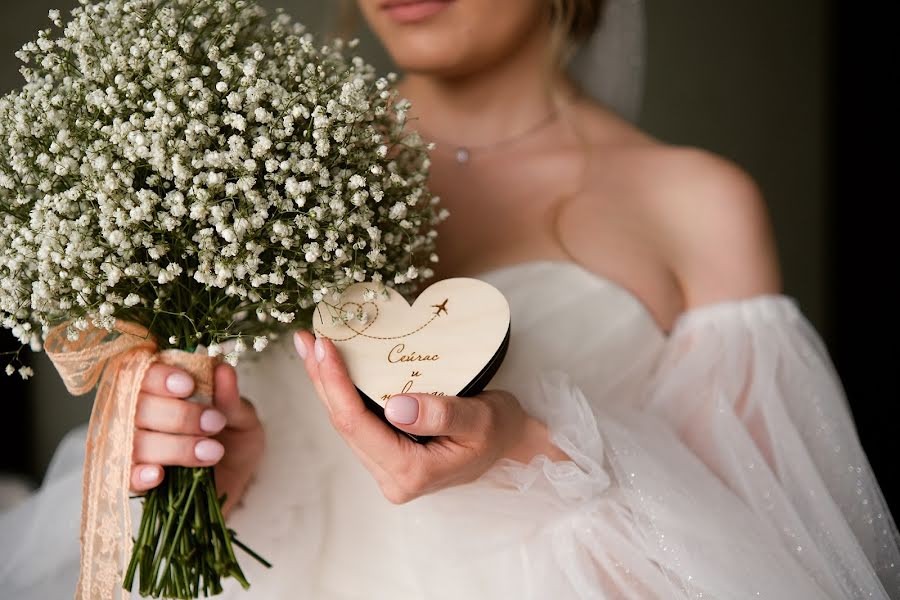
left=0, top=0, right=900, bottom=600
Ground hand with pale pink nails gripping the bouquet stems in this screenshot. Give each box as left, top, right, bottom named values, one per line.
left=131, top=363, right=265, bottom=514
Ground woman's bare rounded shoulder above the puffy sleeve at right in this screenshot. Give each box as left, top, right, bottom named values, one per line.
left=634, top=145, right=780, bottom=308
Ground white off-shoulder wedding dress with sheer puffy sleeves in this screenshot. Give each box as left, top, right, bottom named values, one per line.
left=0, top=262, right=900, bottom=600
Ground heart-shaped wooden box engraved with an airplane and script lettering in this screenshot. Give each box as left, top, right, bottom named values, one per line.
left=313, top=277, right=510, bottom=442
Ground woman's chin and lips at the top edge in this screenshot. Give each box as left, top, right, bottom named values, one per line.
left=358, top=0, right=548, bottom=77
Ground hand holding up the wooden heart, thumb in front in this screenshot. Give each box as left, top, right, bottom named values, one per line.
left=294, top=331, right=568, bottom=504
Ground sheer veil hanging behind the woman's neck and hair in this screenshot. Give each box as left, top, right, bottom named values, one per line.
left=569, top=0, right=646, bottom=121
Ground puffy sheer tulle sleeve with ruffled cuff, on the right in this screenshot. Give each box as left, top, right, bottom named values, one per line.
left=406, top=296, right=900, bottom=599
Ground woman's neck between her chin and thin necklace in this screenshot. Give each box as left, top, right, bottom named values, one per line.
left=400, top=27, right=568, bottom=146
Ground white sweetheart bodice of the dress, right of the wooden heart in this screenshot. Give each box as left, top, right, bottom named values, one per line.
left=479, top=261, right=666, bottom=402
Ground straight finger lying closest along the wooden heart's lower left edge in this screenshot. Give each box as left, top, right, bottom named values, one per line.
left=314, top=338, right=404, bottom=471
